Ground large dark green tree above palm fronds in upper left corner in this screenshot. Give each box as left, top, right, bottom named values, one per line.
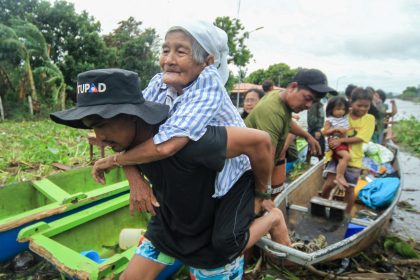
left=0, top=0, right=115, bottom=99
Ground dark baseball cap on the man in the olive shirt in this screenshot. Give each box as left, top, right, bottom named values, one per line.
left=293, top=69, right=338, bottom=95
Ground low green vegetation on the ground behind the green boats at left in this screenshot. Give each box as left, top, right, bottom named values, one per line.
left=0, top=120, right=89, bottom=185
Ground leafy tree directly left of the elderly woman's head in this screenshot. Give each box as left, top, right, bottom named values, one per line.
left=104, top=17, right=160, bottom=85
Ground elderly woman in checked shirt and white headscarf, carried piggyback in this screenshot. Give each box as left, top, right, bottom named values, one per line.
left=90, top=20, right=251, bottom=214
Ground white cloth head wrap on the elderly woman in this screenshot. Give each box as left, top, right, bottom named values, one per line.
left=169, top=20, right=229, bottom=84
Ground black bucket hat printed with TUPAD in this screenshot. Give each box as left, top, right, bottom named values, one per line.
left=50, top=69, right=169, bottom=129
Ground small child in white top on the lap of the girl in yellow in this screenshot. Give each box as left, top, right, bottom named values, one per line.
left=322, top=96, right=354, bottom=188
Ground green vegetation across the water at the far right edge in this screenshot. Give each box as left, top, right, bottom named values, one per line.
left=392, top=117, right=420, bottom=156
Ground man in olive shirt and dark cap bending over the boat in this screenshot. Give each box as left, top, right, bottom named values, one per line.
left=245, top=69, right=337, bottom=196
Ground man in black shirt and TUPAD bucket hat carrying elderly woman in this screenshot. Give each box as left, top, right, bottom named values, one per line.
left=50, top=69, right=290, bottom=279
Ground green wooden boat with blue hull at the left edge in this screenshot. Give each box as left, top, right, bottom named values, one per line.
left=0, top=167, right=129, bottom=262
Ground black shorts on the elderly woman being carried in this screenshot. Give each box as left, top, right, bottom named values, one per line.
left=212, top=171, right=255, bottom=262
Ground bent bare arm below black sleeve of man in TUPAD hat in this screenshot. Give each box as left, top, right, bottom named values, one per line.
left=226, top=127, right=273, bottom=195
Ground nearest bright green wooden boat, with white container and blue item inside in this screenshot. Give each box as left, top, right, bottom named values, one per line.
left=19, top=194, right=181, bottom=279
